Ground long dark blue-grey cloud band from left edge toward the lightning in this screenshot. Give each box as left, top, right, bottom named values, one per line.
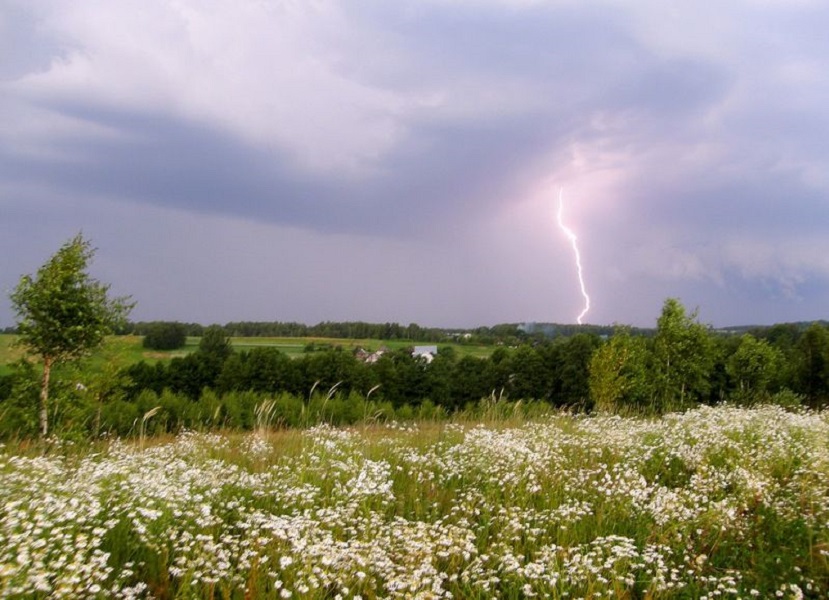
left=0, top=107, right=544, bottom=235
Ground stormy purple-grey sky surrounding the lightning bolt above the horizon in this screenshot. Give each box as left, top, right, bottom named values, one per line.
left=0, top=0, right=829, bottom=327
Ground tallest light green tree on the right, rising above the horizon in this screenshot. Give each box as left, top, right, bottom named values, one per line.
left=653, top=298, right=714, bottom=412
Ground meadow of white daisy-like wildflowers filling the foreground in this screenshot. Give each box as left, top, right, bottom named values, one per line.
left=0, top=407, right=829, bottom=599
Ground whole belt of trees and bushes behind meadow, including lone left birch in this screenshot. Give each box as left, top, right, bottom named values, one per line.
left=0, top=236, right=829, bottom=437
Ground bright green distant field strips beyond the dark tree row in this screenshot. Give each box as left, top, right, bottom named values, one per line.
left=0, top=334, right=495, bottom=375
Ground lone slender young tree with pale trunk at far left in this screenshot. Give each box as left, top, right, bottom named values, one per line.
left=11, top=234, right=134, bottom=437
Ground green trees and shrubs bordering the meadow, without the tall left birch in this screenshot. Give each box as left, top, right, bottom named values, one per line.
left=0, top=299, right=829, bottom=439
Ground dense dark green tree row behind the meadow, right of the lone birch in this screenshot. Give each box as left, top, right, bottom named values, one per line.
left=124, top=298, right=829, bottom=413
